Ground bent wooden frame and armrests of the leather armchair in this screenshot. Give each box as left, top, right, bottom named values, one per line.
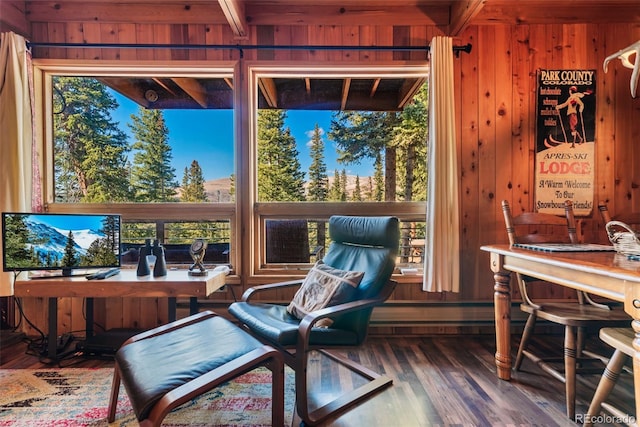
left=235, top=280, right=397, bottom=425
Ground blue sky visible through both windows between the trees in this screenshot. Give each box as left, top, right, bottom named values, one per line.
left=111, top=92, right=373, bottom=182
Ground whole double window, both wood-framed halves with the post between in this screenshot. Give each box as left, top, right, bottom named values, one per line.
left=35, top=60, right=428, bottom=281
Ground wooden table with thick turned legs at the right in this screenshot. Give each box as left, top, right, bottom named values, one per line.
left=480, top=245, right=640, bottom=416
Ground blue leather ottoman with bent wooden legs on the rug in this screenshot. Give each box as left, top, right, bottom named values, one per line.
left=108, top=311, right=284, bottom=426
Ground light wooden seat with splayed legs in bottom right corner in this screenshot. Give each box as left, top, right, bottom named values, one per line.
left=584, top=328, right=638, bottom=426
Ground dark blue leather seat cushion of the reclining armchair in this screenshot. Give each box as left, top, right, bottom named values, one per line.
left=229, top=302, right=360, bottom=347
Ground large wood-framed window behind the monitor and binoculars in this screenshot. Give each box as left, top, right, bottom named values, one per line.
left=35, top=62, right=235, bottom=270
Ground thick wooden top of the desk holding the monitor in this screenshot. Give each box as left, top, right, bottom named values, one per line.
left=14, top=269, right=226, bottom=298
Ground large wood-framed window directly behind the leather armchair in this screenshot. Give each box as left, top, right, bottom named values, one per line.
left=251, top=67, right=428, bottom=272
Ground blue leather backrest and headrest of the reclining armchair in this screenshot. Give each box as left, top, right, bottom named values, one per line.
left=323, top=215, right=400, bottom=340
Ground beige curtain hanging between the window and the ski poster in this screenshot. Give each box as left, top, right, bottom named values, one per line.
left=424, top=37, right=460, bottom=292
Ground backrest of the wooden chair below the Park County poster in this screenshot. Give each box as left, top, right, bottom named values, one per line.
left=502, top=200, right=579, bottom=245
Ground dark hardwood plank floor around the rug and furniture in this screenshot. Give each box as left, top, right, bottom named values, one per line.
left=0, top=335, right=633, bottom=427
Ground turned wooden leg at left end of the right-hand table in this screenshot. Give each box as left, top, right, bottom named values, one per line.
left=491, top=253, right=511, bottom=380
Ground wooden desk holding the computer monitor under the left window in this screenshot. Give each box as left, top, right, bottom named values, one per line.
left=14, top=269, right=226, bottom=358
